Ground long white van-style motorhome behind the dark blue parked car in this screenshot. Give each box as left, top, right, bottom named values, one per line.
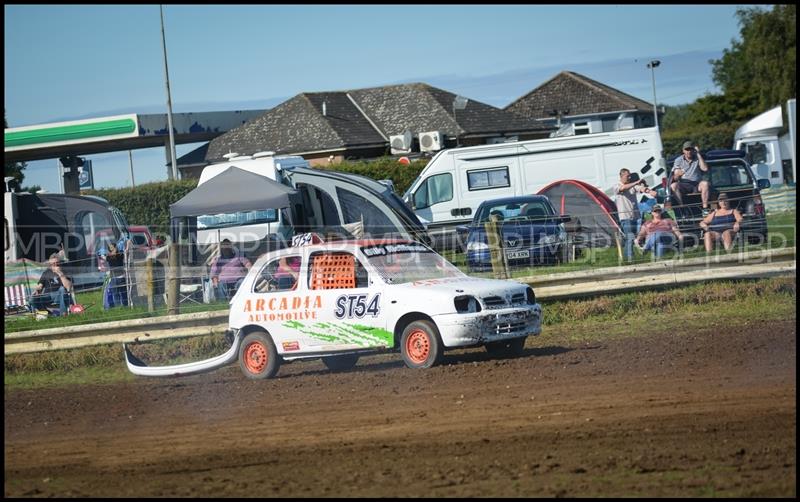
left=403, top=128, right=665, bottom=248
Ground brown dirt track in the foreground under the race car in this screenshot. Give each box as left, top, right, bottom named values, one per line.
left=4, top=319, right=797, bottom=497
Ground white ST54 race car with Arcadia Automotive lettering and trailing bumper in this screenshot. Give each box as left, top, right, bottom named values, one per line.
left=124, top=240, right=542, bottom=379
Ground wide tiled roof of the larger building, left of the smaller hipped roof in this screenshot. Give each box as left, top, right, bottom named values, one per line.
left=191, top=83, right=552, bottom=171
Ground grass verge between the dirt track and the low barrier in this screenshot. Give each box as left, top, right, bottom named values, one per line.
left=4, top=277, right=797, bottom=391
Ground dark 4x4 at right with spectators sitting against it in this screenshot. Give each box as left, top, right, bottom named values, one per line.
left=667, top=150, right=771, bottom=246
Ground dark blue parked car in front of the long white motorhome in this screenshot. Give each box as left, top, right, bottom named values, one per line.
left=459, top=195, right=571, bottom=271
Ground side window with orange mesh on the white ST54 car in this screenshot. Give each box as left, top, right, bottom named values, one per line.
left=308, top=251, right=369, bottom=290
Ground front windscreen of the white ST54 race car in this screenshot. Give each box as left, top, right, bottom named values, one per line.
left=361, top=243, right=464, bottom=284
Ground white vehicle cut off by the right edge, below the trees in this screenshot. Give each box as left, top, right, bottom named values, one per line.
left=733, top=98, right=797, bottom=186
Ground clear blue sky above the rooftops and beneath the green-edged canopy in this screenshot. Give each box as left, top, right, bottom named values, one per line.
left=4, top=5, right=756, bottom=192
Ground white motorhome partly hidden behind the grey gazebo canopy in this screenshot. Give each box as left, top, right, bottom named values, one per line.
left=197, top=152, right=310, bottom=245
